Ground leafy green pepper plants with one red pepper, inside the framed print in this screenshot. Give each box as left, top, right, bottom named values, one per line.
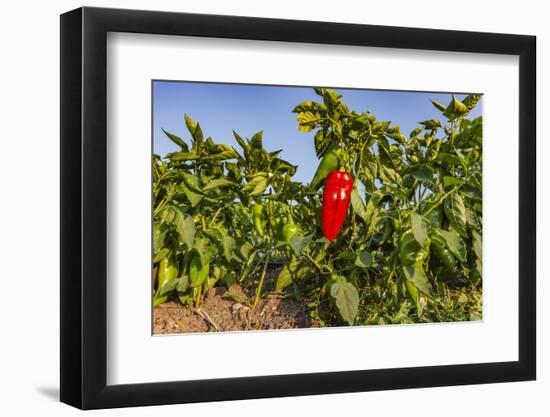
left=153, top=88, right=482, bottom=325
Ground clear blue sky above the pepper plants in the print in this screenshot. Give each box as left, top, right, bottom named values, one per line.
left=153, top=81, right=482, bottom=183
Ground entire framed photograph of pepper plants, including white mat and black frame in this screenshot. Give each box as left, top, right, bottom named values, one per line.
left=61, top=7, right=536, bottom=409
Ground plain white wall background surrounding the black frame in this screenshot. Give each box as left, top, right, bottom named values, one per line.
left=0, top=0, right=550, bottom=417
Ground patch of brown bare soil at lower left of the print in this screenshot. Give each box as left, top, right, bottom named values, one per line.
left=153, top=285, right=319, bottom=334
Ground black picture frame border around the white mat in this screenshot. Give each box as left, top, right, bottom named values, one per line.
left=60, top=7, right=536, bottom=409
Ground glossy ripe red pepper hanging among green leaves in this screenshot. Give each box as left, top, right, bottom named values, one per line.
left=322, top=170, right=353, bottom=242
